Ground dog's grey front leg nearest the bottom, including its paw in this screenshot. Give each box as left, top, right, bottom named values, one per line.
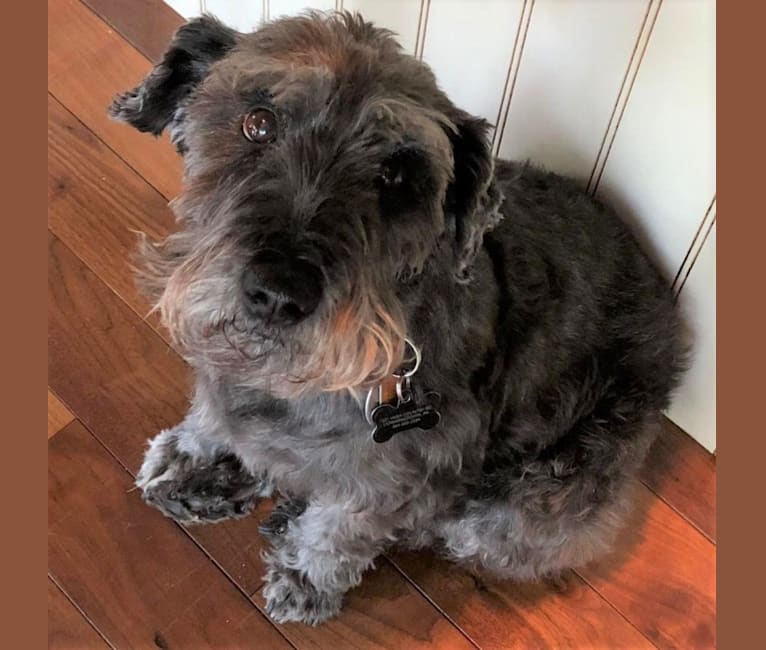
left=263, top=505, right=392, bottom=625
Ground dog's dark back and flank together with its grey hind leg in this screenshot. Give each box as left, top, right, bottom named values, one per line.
left=441, top=161, right=685, bottom=578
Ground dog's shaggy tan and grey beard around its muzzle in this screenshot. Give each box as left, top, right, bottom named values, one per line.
left=138, top=231, right=406, bottom=397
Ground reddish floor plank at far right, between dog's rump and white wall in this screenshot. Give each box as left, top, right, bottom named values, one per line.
left=641, top=418, right=716, bottom=542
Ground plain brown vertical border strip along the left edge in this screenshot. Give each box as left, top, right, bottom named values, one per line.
left=6, top=2, right=47, bottom=648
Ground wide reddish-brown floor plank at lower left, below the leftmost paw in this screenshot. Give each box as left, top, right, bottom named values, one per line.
left=48, top=422, right=289, bottom=648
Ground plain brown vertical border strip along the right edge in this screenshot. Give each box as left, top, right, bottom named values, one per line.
left=716, top=2, right=766, bottom=648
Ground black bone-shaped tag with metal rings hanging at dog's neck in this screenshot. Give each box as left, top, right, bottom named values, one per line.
left=364, top=338, right=441, bottom=442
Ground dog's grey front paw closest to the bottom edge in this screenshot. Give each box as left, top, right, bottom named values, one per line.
left=263, top=569, right=343, bottom=625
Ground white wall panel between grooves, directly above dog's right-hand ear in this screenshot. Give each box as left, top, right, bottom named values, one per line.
left=423, top=0, right=523, bottom=124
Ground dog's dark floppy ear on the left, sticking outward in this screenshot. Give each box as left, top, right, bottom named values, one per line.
left=109, top=15, right=239, bottom=151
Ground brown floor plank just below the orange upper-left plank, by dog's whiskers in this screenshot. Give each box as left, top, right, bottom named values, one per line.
left=48, top=90, right=174, bottom=322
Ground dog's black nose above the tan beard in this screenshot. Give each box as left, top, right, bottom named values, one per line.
left=242, top=252, right=322, bottom=325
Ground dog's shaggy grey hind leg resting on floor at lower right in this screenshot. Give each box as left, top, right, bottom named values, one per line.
left=436, top=410, right=659, bottom=580
